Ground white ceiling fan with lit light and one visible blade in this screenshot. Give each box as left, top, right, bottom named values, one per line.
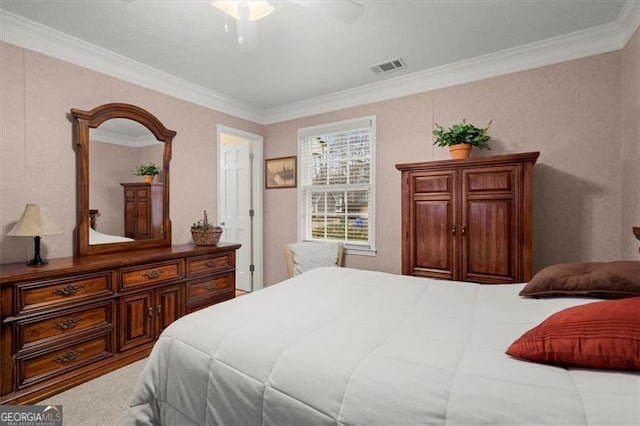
left=212, top=0, right=364, bottom=45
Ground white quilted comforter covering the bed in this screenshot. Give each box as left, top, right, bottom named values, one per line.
left=127, top=267, right=640, bottom=426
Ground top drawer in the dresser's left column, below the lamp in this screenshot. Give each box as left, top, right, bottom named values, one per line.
left=16, top=271, right=114, bottom=314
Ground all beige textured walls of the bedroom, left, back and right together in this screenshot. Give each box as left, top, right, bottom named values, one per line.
left=0, top=34, right=640, bottom=285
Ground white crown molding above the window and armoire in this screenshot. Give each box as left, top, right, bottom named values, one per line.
left=263, top=0, right=640, bottom=124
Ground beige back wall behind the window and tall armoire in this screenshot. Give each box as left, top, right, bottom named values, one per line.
left=265, top=43, right=640, bottom=284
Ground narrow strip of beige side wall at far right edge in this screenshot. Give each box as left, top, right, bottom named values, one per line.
left=621, top=30, right=640, bottom=259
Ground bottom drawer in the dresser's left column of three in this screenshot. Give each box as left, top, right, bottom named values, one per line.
left=16, top=333, right=112, bottom=389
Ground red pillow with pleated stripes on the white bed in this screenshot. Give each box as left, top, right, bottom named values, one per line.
left=507, top=297, right=640, bottom=370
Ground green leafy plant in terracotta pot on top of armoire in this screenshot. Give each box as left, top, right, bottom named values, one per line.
left=433, top=118, right=491, bottom=159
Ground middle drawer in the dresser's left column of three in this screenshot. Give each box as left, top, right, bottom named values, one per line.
left=16, top=301, right=116, bottom=353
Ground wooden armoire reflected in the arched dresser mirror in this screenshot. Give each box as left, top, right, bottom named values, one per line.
left=120, top=182, right=163, bottom=240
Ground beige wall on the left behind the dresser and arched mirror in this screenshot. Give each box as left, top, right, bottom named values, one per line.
left=0, top=43, right=262, bottom=263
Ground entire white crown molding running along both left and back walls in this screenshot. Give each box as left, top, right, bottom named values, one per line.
left=0, top=0, right=640, bottom=125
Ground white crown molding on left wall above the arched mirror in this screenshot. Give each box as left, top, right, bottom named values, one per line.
left=0, top=9, right=263, bottom=123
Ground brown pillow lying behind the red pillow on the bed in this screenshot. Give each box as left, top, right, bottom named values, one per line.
left=520, top=261, right=640, bottom=299
